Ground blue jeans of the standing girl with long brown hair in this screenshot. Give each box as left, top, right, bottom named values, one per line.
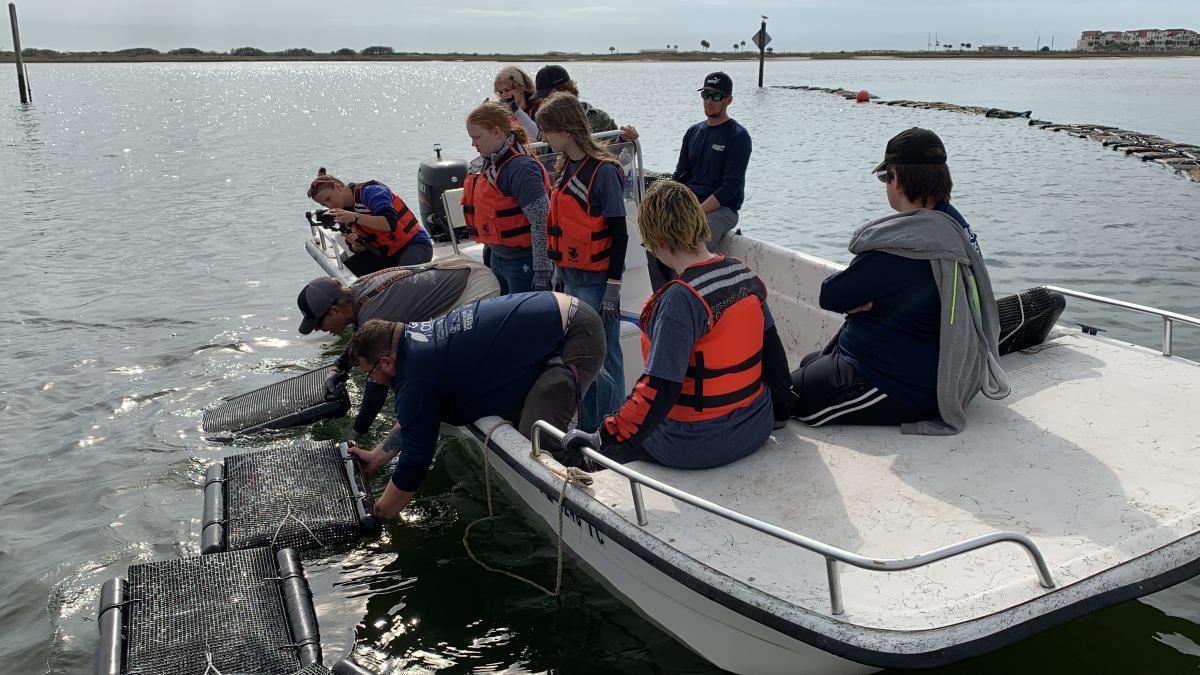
left=558, top=268, right=625, bottom=432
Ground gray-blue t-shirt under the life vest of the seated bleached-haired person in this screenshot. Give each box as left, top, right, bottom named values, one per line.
left=643, top=283, right=775, bottom=468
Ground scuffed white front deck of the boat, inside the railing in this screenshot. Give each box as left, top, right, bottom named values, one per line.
left=580, top=331, right=1200, bottom=629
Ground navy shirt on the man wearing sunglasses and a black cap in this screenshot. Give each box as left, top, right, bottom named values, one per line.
left=672, top=119, right=751, bottom=211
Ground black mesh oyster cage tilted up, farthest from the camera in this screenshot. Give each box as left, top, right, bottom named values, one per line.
left=200, top=364, right=350, bottom=434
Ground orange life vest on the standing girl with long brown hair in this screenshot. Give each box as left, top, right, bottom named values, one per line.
left=546, top=157, right=612, bottom=271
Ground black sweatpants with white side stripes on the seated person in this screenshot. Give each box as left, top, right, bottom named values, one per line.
left=792, top=350, right=937, bottom=426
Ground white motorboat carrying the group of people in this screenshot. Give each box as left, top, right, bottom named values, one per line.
left=307, top=133, right=1200, bottom=675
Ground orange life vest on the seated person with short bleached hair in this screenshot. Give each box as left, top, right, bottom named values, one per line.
left=641, top=256, right=767, bottom=422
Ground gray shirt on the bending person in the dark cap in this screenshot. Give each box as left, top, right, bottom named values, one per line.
left=350, top=268, right=470, bottom=325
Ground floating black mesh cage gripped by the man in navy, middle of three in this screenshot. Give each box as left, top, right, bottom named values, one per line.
left=200, top=441, right=379, bottom=554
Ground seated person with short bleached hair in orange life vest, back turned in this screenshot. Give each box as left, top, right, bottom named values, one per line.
left=564, top=180, right=793, bottom=468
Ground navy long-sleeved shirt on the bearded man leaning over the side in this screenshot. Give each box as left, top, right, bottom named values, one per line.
left=391, top=293, right=563, bottom=492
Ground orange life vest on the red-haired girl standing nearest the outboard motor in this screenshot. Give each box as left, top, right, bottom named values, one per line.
left=460, top=143, right=550, bottom=249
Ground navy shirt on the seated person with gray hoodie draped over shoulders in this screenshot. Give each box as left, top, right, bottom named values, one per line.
left=821, top=251, right=942, bottom=414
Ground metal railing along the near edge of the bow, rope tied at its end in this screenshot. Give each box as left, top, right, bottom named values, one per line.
left=533, top=420, right=1055, bottom=615
